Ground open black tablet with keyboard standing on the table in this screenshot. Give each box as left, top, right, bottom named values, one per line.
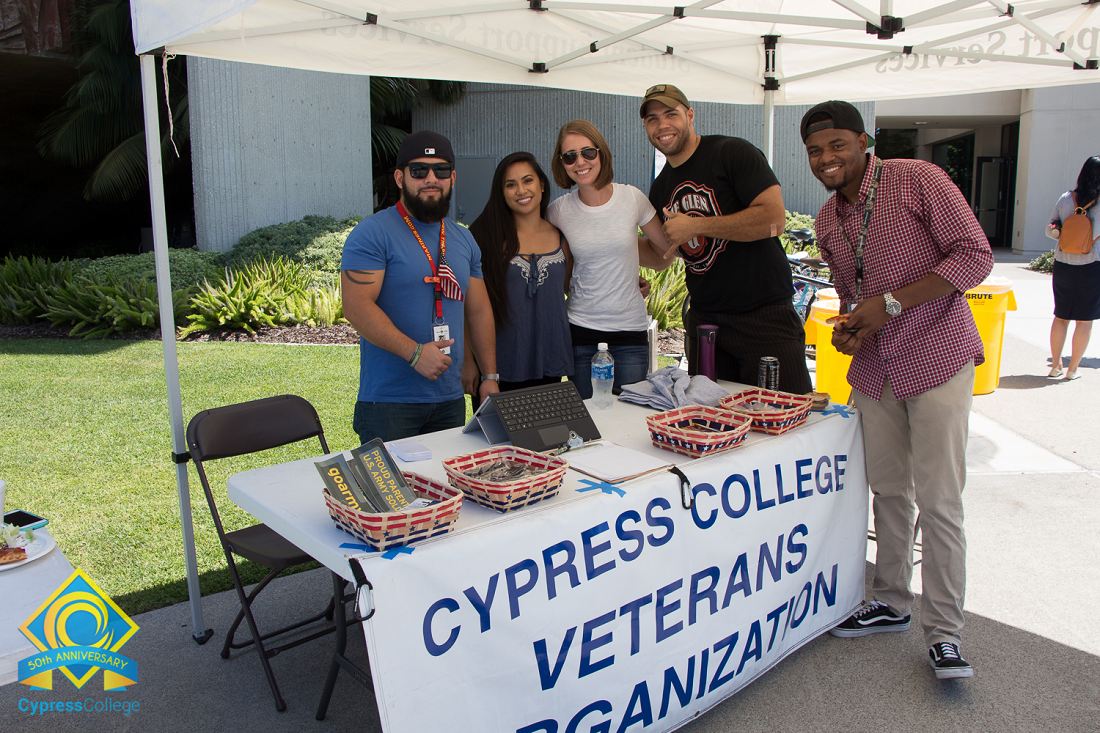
left=462, top=381, right=601, bottom=452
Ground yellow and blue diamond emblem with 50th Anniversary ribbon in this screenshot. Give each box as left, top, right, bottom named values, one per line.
left=19, top=570, right=138, bottom=691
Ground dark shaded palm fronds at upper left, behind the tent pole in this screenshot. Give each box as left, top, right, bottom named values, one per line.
left=37, top=0, right=190, bottom=201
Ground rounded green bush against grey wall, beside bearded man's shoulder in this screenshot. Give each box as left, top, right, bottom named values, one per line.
left=226, top=216, right=362, bottom=279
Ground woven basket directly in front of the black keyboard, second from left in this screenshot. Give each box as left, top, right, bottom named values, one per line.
left=443, top=446, right=569, bottom=512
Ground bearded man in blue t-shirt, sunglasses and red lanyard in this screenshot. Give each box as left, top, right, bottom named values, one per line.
left=340, top=130, right=498, bottom=442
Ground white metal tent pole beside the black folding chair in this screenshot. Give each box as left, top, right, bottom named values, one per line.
left=140, top=54, right=213, bottom=644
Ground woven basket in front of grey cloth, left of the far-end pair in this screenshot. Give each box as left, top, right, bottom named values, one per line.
left=646, top=405, right=751, bottom=458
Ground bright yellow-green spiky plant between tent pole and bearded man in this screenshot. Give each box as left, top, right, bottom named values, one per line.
left=179, top=256, right=343, bottom=338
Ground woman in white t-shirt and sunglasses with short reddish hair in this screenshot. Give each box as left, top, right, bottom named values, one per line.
left=547, top=120, right=672, bottom=400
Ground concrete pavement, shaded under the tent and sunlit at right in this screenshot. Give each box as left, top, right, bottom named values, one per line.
left=0, top=256, right=1100, bottom=733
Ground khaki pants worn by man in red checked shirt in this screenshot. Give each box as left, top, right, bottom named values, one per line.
left=853, top=362, right=974, bottom=646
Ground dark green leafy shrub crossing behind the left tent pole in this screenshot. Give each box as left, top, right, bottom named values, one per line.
left=34, top=273, right=194, bottom=339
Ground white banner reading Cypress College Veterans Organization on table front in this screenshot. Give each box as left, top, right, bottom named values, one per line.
left=363, top=414, right=868, bottom=733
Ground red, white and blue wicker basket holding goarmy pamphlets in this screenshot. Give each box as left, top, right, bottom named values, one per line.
left=325, top=471, right=462, bottom=550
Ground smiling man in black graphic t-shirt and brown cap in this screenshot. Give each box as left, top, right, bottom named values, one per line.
left=641, top=84, right=813, bottom=394
